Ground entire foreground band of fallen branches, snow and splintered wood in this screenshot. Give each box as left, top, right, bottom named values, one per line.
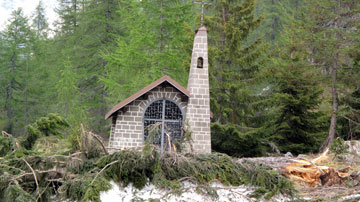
left=0, top=115, right=360, bottom=202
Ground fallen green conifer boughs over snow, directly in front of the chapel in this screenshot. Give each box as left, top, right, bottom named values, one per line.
left=97, top=147, right=294, bottom=198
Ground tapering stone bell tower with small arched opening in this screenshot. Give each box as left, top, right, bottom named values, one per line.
left=186, top=26, right=211, bottom=153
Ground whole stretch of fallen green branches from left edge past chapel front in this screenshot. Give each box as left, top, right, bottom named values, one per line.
left=0, top=120, right=294, bottom=202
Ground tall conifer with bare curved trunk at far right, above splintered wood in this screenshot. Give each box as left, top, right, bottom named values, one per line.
left=305, top=0, right=359, bottom=149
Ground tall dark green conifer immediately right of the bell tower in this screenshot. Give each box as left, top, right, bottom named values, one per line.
left=205, top=0, right=270, bottom=156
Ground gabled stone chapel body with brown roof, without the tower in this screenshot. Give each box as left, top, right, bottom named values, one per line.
left=105, top=76, right=189, bottom=151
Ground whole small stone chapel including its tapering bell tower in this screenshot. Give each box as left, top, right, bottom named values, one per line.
left=105, top=26, right=211, bottom=153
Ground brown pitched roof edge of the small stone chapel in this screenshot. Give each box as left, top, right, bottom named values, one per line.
left=105, top=75, right=190, bottom=119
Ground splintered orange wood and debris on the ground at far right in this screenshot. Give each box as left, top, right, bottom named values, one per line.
left=239, top=141, right=360, bottom=202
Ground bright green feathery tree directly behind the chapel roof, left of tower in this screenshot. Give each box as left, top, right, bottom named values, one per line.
left=102, top=0, right=193, bottom=103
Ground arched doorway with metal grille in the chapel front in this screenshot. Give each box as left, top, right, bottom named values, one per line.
left=143, top=99, right=184, bottom=151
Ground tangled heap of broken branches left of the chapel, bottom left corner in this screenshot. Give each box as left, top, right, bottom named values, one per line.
left=0, top=119, right=111, bottom=202
